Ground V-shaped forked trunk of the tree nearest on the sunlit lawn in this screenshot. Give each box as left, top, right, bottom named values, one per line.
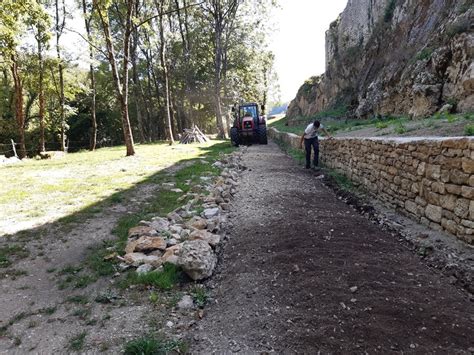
left=96, top=0, right=135, bottom=156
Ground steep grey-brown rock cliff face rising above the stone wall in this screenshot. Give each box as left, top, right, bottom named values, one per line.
left=287, top=0, right=474, bottom=118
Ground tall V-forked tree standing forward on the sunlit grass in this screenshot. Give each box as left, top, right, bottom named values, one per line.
left=94, top=0, right=135, bottom=156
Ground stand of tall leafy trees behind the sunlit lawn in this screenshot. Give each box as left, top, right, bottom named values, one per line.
left=0, top=0, right=275, bottom=157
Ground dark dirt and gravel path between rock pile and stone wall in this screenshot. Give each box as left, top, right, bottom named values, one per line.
left=191, top=143, right=474, bottom=354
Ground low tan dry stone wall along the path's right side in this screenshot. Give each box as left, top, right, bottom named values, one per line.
left=269, top=128, right=474, bottom=244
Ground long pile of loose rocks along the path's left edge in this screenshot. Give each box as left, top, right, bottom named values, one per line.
left=120, top=151, right=242, bottom=280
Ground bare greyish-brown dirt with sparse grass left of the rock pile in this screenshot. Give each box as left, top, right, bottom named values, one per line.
left=0, top=170, right=185, bottom=354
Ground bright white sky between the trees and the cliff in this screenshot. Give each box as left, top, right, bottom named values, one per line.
left=270, top=0, right=347, bottom=102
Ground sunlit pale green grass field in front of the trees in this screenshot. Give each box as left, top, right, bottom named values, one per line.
left=0, top=141, right=230, bottom=235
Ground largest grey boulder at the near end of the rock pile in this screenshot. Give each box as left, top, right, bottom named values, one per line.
left=178, top=240, right=217, bottom=280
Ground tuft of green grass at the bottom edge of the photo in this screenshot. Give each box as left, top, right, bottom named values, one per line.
left=124, top=335, right=187, bottom=355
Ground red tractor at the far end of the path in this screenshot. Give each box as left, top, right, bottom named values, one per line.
left=230, top=103, right=268, bottom=147
